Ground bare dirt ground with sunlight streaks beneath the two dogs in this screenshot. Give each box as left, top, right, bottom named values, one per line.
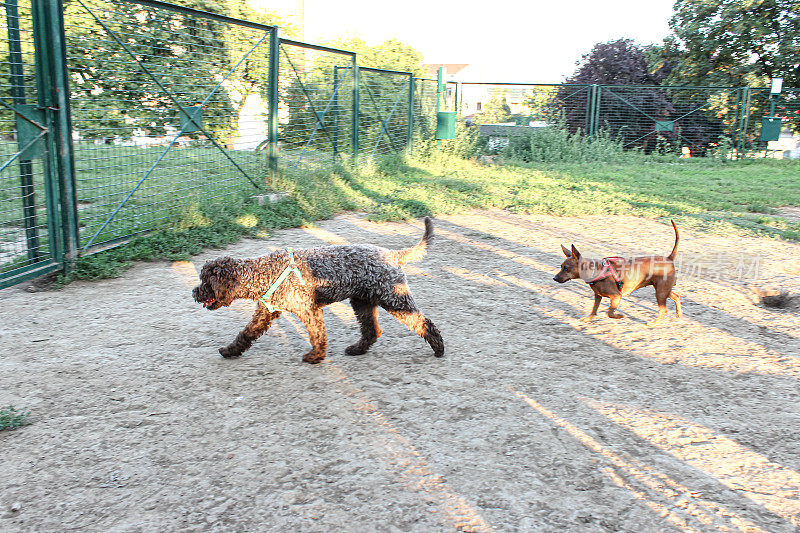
left=0, top=211, right=800, bottom=532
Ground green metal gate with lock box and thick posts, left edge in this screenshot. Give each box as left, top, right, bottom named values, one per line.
left=0, top=0, right=75, bottom=288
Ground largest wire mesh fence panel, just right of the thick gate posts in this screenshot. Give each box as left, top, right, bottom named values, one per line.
left=64, top=0, right=272, bottom=251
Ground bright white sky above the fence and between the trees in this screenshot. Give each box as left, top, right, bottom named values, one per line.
left=250, top=0, right=675, bottom=83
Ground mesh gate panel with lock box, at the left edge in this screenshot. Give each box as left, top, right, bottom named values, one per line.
left=0, top=0, right=57, bottom=286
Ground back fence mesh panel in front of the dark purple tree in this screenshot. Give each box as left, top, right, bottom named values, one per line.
left=595, top=86, right=739, bottom=156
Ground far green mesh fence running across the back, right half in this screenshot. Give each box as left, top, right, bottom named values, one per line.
left=459, top=83, right=800, bottom=158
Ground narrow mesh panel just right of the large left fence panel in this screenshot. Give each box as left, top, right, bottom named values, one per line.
left=278, top=39, right=354, bottom=168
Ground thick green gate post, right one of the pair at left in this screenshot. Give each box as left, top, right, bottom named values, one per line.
left=45, top=0, right=80, bottom=266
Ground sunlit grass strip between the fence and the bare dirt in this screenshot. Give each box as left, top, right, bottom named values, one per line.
left=50, top=140, right=800, bottom=284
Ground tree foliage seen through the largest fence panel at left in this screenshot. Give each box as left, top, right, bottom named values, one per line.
left=64, top=0, right=288, bottom=143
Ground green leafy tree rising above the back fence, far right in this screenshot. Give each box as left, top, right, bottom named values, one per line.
left=664, top=0, right=800, bottom=87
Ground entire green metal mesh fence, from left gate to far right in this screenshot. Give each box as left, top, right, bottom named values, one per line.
left=0, top=0, right=800, bottom=288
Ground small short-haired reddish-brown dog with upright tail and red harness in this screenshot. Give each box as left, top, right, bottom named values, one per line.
left=553, top=221, right=683, bottom=325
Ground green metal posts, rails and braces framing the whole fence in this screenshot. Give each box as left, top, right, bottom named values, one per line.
left=0, top=0, right=800, bottom=289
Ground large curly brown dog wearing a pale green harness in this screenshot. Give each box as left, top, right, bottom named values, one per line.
left=192, top=217, right=444, bottom=363
